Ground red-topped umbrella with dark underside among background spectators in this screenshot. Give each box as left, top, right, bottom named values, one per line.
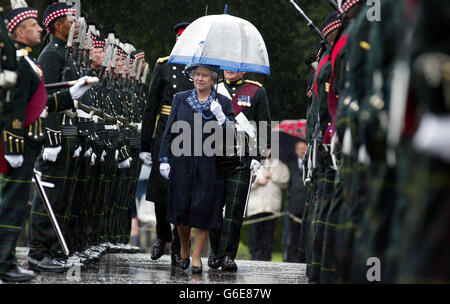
left=272, top=119, right=306, bottom=164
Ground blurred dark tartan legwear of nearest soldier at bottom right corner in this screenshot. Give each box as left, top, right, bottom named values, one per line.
left=395, top=151, right=450, bottom=284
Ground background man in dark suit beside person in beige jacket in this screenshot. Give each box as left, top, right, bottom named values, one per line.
left=283, top=141, right=307, bottom=263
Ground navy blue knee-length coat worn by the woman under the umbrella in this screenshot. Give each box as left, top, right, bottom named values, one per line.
left=160, top=89, right=234, bottom=229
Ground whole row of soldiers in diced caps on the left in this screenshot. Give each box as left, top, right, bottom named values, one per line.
left=0, top=1, right=149, bottom=281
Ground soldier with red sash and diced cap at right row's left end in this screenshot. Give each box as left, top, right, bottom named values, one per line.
left=306, top=12, right=342, bottom=282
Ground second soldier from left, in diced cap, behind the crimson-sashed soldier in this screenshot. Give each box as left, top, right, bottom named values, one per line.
left=29, top=2, right=86, bottom=268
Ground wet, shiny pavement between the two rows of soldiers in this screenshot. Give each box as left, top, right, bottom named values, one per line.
left=12, top=248, right=308, bottom=284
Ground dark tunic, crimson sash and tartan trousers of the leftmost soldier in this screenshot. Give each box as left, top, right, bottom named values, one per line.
left=0, top=42, right=73, bottom=273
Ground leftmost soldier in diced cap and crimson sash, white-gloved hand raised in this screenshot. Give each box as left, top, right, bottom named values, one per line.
left=0, top=4, right=90, bottom=282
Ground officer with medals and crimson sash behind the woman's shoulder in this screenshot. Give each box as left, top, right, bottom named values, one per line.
left=208, top=71, right=271, bottom=271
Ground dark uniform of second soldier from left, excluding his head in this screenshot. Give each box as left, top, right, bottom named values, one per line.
left=29, top=38, right=78, bottom=260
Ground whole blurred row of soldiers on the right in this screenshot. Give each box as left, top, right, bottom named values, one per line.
left=299, top=0, right=450, bottom=283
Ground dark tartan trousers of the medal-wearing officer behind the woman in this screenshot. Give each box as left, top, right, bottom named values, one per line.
left=209, top=168, right=251, bottom=259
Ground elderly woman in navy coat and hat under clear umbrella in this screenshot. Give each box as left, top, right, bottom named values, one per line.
left=160, top=65, right=234, bottom=274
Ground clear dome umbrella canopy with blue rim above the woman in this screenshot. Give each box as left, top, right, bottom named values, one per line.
left=169, top=14, right=270, bottom=75
